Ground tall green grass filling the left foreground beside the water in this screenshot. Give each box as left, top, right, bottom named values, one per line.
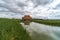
left=0, top=18, right=30, bottom=40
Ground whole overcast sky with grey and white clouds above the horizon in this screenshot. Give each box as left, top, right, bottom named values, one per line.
left=0, top=0, right=60, bottom=19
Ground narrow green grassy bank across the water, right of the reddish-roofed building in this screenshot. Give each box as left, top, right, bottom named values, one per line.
left=33, top=20, right=60, bottom=26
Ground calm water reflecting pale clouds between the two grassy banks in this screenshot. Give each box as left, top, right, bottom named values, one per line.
left=21, top=22, right=60, bottom=40
